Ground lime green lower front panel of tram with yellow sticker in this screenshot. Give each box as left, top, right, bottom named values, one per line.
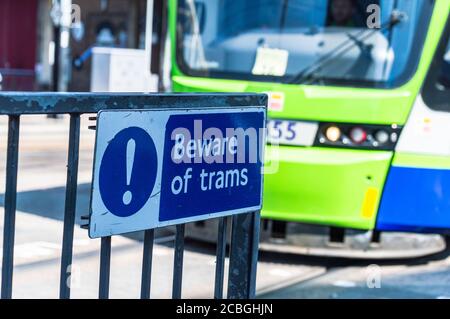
left=262, top=145, right=393, bottom=230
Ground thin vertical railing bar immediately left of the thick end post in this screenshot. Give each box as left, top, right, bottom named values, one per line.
left=214, top=217, right=228, bottom=299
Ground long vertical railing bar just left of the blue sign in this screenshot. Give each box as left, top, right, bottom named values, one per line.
left=59, top=114, right=80, bottom=299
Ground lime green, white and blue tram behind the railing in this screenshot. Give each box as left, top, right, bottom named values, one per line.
left=169, top=0, right=450, bottom=258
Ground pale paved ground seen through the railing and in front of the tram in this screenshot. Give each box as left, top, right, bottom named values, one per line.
left=0, top=117, right=450, bottom=298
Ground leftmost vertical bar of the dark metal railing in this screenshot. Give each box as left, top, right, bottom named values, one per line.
left=1, top=115, right=20, bottom=299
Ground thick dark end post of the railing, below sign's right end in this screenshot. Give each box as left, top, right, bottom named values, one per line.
left=228, top=212, right=260, bottom=299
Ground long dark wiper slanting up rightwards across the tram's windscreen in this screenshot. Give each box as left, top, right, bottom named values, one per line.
left=286, top=11, right=407, bottom=84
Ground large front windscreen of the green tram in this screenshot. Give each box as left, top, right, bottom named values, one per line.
left=176, top=0, right=434, bottom=87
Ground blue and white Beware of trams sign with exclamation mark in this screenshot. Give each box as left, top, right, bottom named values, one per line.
left=89, top=106, right=265, bottom=238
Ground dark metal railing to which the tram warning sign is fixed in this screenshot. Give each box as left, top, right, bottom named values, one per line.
left=0, top=92, right=267, bottom=299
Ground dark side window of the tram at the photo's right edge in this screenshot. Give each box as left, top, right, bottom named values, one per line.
left=423, top=17, right=450, bottom=112
